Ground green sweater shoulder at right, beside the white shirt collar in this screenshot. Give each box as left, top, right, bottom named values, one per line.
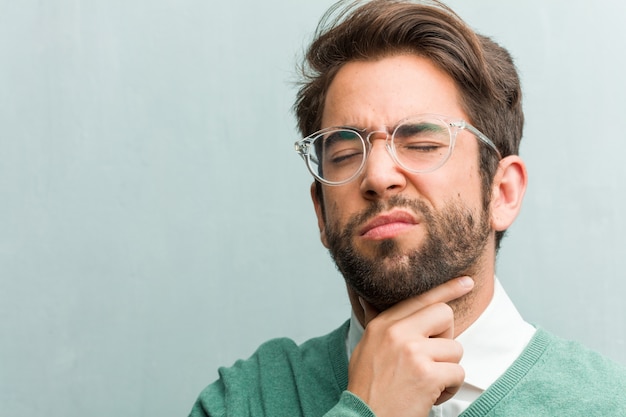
left=463, top=329, right=626, bottom=417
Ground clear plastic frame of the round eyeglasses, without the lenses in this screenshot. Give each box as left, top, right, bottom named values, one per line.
left=294, top=113, right=502, bottom=186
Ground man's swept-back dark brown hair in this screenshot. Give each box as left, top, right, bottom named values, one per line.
left=294, top=0, right=524, bottom=247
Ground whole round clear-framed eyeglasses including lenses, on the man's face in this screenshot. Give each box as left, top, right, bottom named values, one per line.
left=295, top=114, right=501, bottom=185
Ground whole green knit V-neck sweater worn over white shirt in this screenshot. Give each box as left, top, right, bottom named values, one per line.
left=190, top=323, right=626, bottom=417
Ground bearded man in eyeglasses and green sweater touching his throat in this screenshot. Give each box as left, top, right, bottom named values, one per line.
left=191, top=0, right=626, bottom=417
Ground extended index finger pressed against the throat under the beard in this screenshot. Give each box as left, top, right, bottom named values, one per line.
left=385, top=277, right=474, bottom=320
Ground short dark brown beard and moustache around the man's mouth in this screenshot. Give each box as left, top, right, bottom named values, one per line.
left=326, top=196, right=491, bottom=311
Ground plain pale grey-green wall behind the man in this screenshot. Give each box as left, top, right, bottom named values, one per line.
left=0, top=0, right=626, bottom=417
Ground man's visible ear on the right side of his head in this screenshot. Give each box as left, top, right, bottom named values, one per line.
left=491, top=155, right=528, bottom=231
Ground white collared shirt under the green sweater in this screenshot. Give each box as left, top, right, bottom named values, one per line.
left=346, top=278, right=536, bottom=417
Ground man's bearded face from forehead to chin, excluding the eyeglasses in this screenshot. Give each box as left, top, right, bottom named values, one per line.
left=314, top=55, right=493, bottom=310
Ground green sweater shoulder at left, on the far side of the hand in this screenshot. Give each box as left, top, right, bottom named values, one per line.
left=188, top=322, right=348, bottom=416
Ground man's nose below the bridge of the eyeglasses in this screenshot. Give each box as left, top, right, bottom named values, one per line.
left=361, top=132, right=406, bottom=200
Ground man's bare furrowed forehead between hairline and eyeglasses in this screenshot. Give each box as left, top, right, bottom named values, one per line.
left=321, top=54, right=466, bottom=128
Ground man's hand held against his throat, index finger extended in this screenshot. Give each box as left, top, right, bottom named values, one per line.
left=348, top=277, right=474, bottom=417
